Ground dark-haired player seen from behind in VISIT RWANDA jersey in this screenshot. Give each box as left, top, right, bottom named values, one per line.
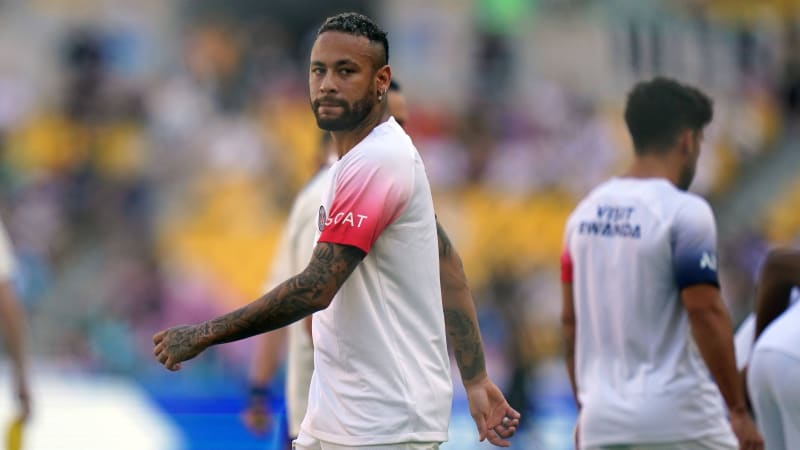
left=562, top=77, right=762, bottom=449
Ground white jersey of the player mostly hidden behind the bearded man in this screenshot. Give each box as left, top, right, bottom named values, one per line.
left=265, top=170, right=326, bottom=436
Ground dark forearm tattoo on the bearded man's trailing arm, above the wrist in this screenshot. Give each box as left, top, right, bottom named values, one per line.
left=444, top=309, right=486, bottom=382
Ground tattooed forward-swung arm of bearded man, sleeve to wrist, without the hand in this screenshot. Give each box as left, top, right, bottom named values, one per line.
left=201, top=242, right=365, bottom=344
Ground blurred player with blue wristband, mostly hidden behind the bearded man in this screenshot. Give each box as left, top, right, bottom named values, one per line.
left=243, top=80, right=408, bottom=446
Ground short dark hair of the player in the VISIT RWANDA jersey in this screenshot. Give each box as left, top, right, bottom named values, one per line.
left=625, top=77, right=714, bottom=154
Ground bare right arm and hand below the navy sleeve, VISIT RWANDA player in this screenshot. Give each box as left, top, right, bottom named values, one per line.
left=681, top=284, right=764, bottom=449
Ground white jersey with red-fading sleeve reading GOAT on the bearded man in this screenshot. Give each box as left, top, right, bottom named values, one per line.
left=301, top=118, right=452, bottom=446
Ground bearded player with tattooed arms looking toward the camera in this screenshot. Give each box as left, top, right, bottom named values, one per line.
left=153, top=13, right=520, bottom=450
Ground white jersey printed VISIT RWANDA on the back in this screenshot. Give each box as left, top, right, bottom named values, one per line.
left=562, top=178, right=733, bottom=446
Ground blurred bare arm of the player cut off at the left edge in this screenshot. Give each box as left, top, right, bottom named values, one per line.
left=0, top=282, right=30, bottom=419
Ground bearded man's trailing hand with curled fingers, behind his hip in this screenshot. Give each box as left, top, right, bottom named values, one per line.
left=465, top=377, right=520, bottom=447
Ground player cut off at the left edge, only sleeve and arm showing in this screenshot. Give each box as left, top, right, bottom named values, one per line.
left=0, top=220, right=31, bottom=422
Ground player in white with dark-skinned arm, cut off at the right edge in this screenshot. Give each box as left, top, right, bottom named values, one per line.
left=747, top=248, right=800, bottom=450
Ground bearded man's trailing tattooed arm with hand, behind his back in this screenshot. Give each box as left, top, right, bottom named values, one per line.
left=436, top=221, right=520, bottom=447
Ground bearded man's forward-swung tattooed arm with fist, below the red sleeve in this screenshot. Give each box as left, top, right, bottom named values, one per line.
left=153, top=242, right=366, bottom=370
